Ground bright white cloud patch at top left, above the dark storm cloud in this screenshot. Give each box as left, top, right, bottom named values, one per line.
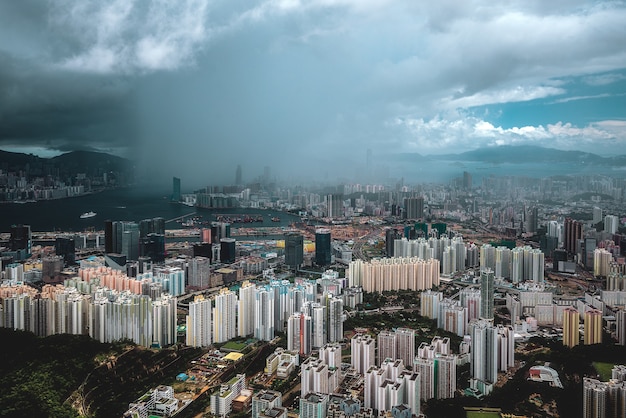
left=50, top=0, right=208, bottom=74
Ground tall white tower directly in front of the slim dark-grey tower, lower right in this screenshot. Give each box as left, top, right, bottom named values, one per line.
left=469, top=320, right=498, bottom=394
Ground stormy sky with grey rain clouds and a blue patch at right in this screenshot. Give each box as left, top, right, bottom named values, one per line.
left=0, top=0, right=626, bottom=184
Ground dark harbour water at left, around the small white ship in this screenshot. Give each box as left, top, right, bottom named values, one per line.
left=0, top=188, right=300, bottom=232
